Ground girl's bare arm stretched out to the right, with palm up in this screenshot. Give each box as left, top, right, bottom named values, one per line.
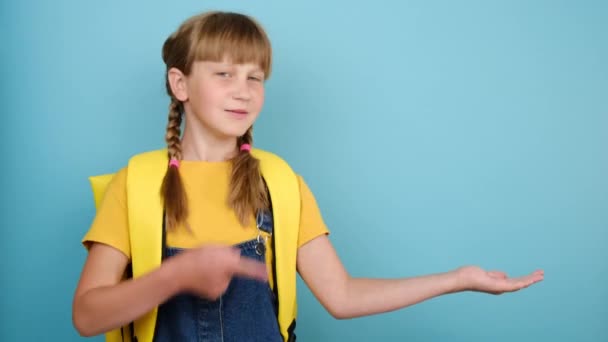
left=297, top=235, right=543, bottom=319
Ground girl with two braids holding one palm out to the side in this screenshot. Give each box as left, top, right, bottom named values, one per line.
left=73, top=12, right=543, bottom=342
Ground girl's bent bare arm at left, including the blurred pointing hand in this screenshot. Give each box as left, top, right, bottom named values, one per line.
left=72, top=243, right=268, bottom=336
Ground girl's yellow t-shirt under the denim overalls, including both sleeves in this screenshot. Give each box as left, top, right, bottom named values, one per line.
left=82, top=161, right=328, bottom=285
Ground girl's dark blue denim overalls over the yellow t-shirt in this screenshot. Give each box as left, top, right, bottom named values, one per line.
left=154, top=212, right=283, bottom=342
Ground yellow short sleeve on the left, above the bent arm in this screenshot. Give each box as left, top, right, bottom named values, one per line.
left=82, top=168, right=131, bottom=259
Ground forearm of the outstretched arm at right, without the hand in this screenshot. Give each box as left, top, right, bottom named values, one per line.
left=332, top=272, right=460, bottom=319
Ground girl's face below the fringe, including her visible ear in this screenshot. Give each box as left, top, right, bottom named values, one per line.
left=169, top=61, right=264, bottom=139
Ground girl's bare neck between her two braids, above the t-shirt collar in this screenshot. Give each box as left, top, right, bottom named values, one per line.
left=182, top=121, right=237, bottom=162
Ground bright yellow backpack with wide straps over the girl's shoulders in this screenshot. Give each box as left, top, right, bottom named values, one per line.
left=89, top=149, right=300, bottom=342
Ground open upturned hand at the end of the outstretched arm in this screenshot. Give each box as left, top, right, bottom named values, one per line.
left=456, top=266, right=544, bottom=295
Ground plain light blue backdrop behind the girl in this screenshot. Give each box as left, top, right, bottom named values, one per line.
left=0, top=0, right=608, bottom=342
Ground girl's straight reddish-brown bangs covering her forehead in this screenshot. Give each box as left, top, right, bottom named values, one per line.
left=190, top=13, right=272, bottom=78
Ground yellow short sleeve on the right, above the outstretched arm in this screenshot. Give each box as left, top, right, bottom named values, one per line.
left=298, top=175, right=329, bottom=247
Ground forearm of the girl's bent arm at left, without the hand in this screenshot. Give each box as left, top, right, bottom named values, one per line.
left=73, top=261, right=180, bottom=336
